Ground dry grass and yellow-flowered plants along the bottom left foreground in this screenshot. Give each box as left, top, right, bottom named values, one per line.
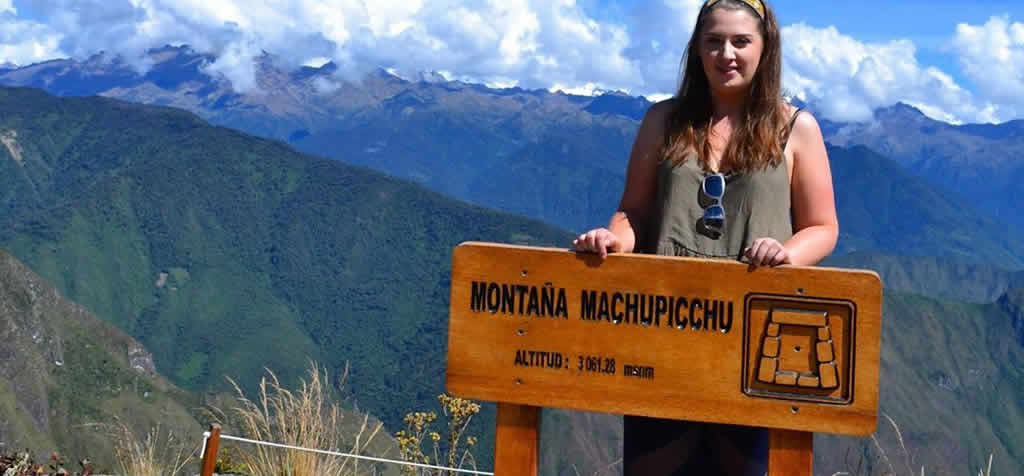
left=0, top=362, right=460, bottom=476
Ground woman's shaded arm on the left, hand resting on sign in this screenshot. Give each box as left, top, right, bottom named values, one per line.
left=572, top=99, right=672, bottom=258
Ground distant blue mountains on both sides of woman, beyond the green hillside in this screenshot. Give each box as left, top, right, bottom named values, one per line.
left=0, top=46, right=1024, bottom=269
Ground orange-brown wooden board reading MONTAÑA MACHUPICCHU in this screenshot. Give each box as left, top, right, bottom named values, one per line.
left=447, top=243, right=882, bottom=435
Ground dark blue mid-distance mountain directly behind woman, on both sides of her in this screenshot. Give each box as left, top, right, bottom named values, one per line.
left=294, top=99, right=1024, bottom=269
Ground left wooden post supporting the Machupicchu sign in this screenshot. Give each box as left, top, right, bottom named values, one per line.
left=495, top=403, right=541, bottom=476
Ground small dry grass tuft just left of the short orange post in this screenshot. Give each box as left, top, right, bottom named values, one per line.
left=109, top=423, right=199, bottom=476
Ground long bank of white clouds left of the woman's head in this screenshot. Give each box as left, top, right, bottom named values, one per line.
left=0, top=0, right=667, bottom=92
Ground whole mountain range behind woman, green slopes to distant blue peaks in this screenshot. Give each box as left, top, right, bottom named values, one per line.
left=0, top=43, right=1024, bottom=474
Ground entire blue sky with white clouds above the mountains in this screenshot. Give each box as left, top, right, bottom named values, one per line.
left=0, top=0, right=1024, bottom=123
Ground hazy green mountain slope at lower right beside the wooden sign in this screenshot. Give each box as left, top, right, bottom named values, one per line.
left=815, top=291, right=1024, bottom=475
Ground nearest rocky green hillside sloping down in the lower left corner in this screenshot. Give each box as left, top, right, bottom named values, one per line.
left=0, top=250, right=202, bottom=466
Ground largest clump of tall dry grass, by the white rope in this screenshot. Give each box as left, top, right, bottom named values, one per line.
left=222, top=362, right=382, bottom=476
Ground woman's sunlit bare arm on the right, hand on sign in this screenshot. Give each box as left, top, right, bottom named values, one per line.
left=745, top=114, right=839, bottom=266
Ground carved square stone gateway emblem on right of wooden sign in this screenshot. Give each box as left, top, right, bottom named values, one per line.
left=743, top=295, right=856, bottom=404
